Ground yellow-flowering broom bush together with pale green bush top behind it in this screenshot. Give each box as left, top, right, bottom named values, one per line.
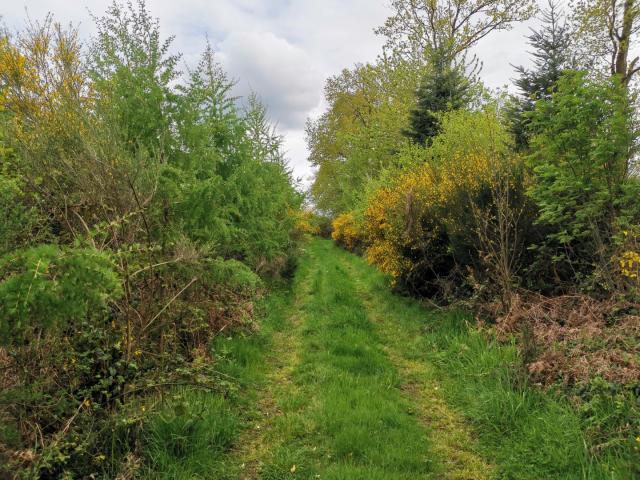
left=362, top=112, right=511, bottom=296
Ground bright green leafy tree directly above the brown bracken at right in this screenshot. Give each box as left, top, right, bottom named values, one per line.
left=528, top=72, right=635, bottom=281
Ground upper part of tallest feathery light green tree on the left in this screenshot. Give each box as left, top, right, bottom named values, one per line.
left=89, top=0, right=180, bottom=156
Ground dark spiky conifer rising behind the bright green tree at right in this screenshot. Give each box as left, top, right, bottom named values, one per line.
left=508, top=1, right=573, bottom=150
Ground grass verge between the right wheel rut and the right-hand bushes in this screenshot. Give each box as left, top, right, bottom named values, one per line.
left=335, top=242, right=640, bottom=480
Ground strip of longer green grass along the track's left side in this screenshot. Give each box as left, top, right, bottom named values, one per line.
left=143, top=288, right=291, bottom=480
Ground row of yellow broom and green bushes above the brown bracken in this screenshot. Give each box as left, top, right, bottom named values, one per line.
left=334, top=72, right=640, bottom=296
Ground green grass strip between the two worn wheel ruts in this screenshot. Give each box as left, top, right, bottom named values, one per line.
left=255, top=242, right=437, bottom=480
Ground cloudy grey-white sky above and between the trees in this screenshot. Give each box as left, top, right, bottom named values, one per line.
left=0, top=0, right=560, bottom=183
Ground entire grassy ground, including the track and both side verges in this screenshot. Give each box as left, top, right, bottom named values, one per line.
left=145, top=240, right=638, bottom=480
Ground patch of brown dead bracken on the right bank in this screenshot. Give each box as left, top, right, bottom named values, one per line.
left=496, top=294, right=640, bottom=385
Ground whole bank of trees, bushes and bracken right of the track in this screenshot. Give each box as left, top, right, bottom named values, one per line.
left=316, top=0, right=640, bottom=474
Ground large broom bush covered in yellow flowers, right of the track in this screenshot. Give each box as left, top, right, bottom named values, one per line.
left=364, top=148, right=493, bottom=295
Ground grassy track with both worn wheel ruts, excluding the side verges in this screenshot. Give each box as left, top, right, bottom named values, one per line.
left=229, top=241, right=492, bottom=480
